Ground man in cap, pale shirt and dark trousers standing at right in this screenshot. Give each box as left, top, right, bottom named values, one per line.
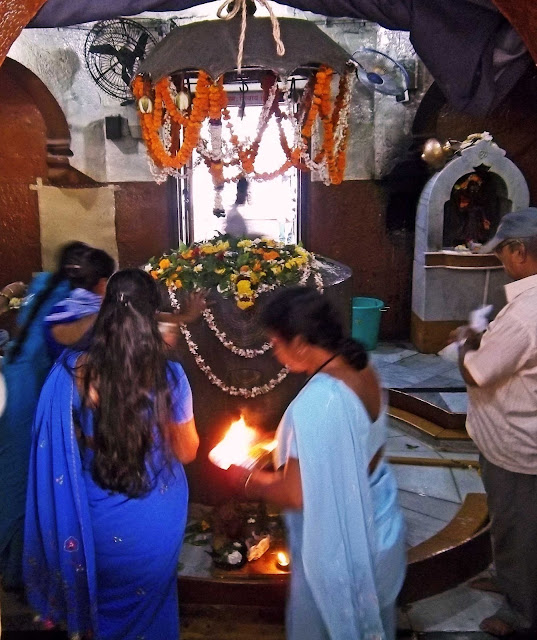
left=459, top=207, right=537, bottom=638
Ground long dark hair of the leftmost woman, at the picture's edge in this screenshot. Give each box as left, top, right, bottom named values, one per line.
left=7, top=241, right=91, bottom=362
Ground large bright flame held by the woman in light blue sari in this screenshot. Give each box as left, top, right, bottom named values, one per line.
left=209, top=416, right=276, bottom=469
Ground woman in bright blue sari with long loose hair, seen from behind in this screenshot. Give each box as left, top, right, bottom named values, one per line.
left=24, top=269, right=199, bottom=640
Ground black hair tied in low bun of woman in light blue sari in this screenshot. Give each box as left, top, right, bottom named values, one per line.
left=260, top=287, right=368, bottom=369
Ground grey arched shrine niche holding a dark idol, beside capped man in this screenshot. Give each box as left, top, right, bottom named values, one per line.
left=411, top=132, right=529, bottom=353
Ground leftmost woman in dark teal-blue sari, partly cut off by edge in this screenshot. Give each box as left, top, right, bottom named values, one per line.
left=0, top=242, right=89, bottom=589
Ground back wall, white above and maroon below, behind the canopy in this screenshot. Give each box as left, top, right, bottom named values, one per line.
left=1, top=13, right=430, bottom=336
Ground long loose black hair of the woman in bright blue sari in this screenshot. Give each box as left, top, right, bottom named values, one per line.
left=83, top=269, right=171, bottom=497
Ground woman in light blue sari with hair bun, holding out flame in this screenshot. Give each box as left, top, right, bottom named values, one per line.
left=228, top=287, right=406, bottom=640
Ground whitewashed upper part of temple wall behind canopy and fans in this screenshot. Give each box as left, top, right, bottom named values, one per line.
left=9, top=13, right=420, bottom=182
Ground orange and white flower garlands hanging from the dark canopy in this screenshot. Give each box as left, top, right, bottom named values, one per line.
left=132, top=66, right=351, bottom=189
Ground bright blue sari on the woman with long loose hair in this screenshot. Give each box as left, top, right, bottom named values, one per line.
left=24, top=353, right=192, bottom=640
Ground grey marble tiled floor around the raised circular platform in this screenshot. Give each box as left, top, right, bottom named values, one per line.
left=2, top=343, right=501, bottom=640
